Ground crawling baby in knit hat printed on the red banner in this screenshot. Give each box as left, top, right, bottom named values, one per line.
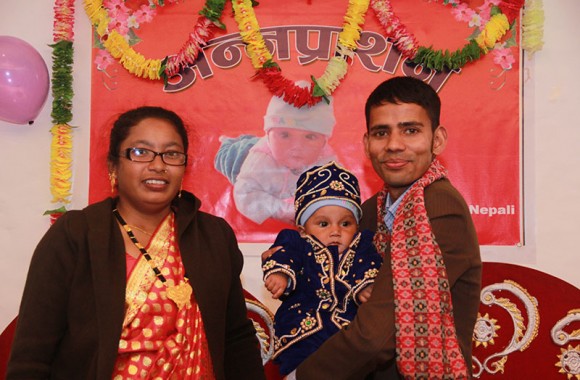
left=214, top=82, right=336, bottom=224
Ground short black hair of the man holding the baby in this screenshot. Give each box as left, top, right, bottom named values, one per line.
left=365, top=77, right=441, bottom=132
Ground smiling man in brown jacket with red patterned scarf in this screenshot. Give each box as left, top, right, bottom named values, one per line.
left=288, top=77, right=481, bottom=380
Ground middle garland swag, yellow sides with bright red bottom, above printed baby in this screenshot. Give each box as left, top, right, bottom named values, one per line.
left=232, top=0, right=369, bottom=107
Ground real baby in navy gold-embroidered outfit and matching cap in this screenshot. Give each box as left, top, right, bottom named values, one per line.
left=262, top=161, right=382, bottom=376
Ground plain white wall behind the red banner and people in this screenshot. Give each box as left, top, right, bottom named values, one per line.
left=0, top=0, right=580, bottom=331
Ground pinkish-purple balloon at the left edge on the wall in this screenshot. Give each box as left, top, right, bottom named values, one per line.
left=0, top=36, right=49, bottom=124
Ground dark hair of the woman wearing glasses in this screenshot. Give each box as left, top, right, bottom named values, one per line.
left=107, top=106, right=189, bottom=165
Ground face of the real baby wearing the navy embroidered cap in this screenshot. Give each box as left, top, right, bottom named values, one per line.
left=303, top=205, right=358, bottom=253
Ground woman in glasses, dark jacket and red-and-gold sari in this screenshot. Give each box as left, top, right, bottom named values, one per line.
left=7, top=107, right=264, bottom=380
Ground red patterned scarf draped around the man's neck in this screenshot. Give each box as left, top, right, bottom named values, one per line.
left=375, top=159, right=469, bottom=379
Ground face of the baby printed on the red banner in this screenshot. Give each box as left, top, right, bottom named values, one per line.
left=268, top=128, right=326, bottom=170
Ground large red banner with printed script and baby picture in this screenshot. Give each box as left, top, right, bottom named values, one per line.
left=89, top=0, right=523, bottom=246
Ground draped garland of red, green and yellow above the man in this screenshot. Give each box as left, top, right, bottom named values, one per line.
left=371, top=0, right=523, bottom=70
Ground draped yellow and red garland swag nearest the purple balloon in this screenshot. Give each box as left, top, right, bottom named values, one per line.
left=84, top=0, right=226, bottom=81
